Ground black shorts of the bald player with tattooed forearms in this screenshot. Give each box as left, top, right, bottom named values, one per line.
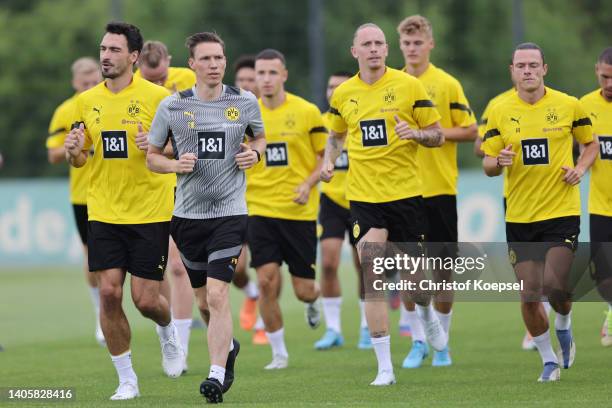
left=351, top=196, right=426, bottom=242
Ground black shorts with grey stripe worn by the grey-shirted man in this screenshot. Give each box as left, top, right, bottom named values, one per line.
left=170, top=215, right=247, bottom=288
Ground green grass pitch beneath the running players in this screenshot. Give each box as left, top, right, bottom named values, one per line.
left=0, top=269, right=612, bottom=407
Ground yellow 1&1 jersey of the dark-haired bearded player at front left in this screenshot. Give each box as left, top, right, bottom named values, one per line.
left=75, top=77, right=176, bottom=224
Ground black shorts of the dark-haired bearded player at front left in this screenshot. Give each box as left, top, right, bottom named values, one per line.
left=87, top=221, right=170, bottom=281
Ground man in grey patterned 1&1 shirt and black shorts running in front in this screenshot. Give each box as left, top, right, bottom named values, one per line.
left=147, top=33, right=266, bottom=402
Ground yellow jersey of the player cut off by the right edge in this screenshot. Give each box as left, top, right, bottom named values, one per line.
left=580, top=89, right=612, bottom=217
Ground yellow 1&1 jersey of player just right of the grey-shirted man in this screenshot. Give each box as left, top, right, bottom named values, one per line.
left=246, top=92, right=327, bottom=221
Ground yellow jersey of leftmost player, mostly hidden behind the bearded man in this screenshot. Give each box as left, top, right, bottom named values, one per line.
left=46, top=95, right=90, bottom=205
